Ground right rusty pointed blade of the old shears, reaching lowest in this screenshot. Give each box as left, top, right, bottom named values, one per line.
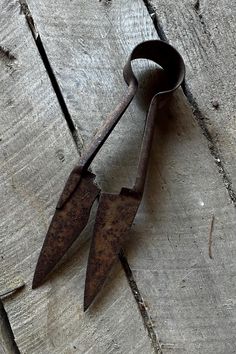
left=84, top=188, right=140, bottom=311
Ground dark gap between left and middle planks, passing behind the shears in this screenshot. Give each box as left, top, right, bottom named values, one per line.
left=15, top=0, right=162, bottom=354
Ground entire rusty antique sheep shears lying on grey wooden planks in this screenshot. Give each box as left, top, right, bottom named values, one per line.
left=32, top=40, right=185, bottom=310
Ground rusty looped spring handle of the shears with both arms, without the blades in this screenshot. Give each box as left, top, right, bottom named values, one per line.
left=57, top=40, right=185, bottom=208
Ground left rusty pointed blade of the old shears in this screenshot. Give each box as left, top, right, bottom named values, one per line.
left=32, top=171, right=100, bottom=289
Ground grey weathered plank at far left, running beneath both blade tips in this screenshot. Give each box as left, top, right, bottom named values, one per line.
left=0, top=1, right=151, bottom=354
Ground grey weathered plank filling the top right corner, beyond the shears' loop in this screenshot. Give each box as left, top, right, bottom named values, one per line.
left=147, top=0, right=236, bottom=192
